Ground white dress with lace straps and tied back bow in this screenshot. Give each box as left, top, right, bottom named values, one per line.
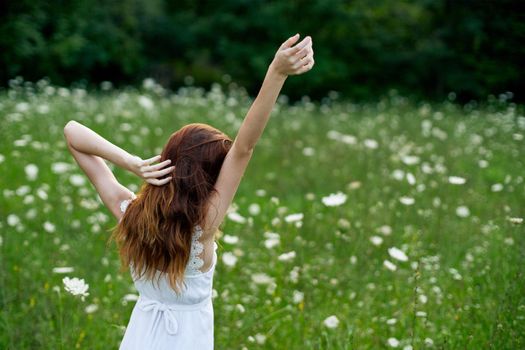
left=119, top=196, right=217, bottom=350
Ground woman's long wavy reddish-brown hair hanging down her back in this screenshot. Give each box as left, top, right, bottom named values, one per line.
left=111, top=123, right=232, bottom=292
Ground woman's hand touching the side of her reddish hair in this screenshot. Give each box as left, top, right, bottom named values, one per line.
left=127, top=155, right=175, bottom=186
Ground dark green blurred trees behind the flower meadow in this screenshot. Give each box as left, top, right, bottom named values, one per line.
left=0, top=0, right=525, bottom=100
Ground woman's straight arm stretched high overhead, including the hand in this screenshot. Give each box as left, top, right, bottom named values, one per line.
left=204, top=34, right=314, bottom=236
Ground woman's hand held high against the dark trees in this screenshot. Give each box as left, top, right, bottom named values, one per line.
left=270, top=34, right=314, bottom=77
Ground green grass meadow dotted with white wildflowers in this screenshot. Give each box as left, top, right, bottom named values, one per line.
left=0, top=80, right=525, bottom=350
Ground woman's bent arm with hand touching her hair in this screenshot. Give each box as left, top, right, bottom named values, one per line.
left=64, top=120, right=173, bottom=219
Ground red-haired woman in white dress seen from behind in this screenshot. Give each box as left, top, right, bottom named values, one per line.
left=64, top=34, right=314, bottom=349
